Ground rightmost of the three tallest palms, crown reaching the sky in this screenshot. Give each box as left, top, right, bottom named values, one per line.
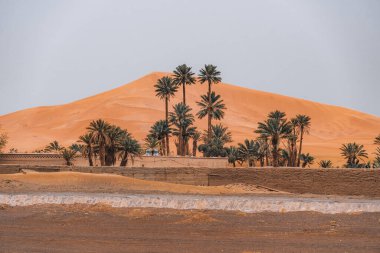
left=198, top=64, right=222, bottom=138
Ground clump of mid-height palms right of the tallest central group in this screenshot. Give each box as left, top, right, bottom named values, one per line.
left=227, top=110, right=314, bottom=167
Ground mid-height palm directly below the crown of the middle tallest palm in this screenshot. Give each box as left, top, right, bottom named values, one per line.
left=169, top=103, right=194, bottom=155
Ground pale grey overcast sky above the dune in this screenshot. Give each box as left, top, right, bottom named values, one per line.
left=0, top=0, right=380, bottom=116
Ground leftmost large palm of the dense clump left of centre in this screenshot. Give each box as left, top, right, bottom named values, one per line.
left=87, top=119, right=111, bottom=166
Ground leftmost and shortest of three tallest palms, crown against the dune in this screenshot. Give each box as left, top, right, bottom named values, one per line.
left=154, top=76, right=178, bottom=155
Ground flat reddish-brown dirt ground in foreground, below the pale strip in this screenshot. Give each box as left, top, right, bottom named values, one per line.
left=0, top=205, right=380, bottom=253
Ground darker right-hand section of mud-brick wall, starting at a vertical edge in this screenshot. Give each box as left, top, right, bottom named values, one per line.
left=209, top=168, right=380, bottom=197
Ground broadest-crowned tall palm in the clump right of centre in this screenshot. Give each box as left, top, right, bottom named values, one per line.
left=255, top=112, right=292, bottom=167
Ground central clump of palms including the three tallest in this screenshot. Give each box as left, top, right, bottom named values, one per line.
left=145, top=64, right=226, bottom=156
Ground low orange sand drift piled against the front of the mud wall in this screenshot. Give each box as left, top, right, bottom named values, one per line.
left=0, top=171, right=284, bottom=195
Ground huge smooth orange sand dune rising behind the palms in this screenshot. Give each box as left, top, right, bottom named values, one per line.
left=0, top=73, right=380, bottom=164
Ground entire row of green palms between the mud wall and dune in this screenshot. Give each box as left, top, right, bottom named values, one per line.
left=33, top=64, right=380, bottom=168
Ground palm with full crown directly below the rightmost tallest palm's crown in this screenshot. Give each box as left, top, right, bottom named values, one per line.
left=197, top=92, right=226, bottom=138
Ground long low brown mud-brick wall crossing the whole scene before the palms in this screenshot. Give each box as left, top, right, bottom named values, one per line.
left=0, top=165, right=380, bottom=197
